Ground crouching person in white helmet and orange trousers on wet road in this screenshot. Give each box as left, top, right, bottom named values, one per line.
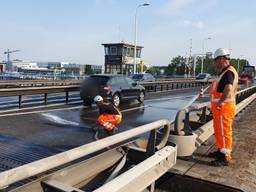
left=94, top=95, right=122, bottom=133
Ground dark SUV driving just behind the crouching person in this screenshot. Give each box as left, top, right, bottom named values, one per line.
left=80, top=74, right=145, bottom=106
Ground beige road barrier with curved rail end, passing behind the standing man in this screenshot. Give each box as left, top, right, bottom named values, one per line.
left=169, top=86, right=256, bottom=156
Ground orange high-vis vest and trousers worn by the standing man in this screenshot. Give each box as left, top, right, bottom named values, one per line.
left=210, top=66, right=238, bottom=160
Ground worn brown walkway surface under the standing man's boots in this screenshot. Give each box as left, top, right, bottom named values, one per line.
left=172, top=101, right=256, bottom=191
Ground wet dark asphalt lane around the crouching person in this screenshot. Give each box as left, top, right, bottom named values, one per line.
left=0, top=90, right=198, bottom=151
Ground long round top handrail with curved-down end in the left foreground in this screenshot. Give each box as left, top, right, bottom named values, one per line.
left=0, top=120, right=171, bottom=189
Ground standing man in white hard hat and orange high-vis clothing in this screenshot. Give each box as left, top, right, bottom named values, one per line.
left=208, top=48, right=238, bottom=166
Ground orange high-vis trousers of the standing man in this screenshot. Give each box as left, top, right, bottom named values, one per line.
left=211, top=102, right=236, bottom=160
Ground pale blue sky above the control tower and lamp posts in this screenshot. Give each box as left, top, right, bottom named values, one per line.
left=0, top=0, right=256, bottom=65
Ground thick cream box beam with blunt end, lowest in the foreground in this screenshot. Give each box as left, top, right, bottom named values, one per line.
left=95, top=146, right=176, bottom=192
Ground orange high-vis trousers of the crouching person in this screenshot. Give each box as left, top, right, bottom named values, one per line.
left=98, top=113, right=122, bottom=131
